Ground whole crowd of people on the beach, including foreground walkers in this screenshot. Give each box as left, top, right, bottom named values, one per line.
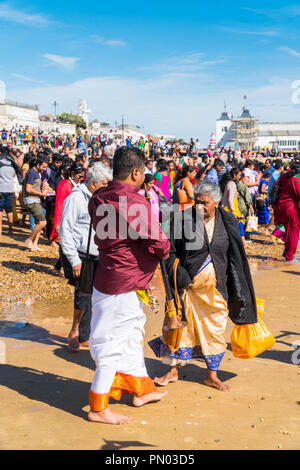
left=0, top=135, right=300, bottom=424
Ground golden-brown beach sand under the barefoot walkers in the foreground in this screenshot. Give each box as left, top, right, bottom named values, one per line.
left=0, top=222, right=300, bottom=451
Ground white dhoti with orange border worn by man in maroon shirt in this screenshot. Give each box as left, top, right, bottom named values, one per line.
left=89, top=288, right=156, bottom=411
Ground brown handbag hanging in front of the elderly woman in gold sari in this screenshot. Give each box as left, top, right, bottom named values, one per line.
left=160, top=258, right=187, bottom=352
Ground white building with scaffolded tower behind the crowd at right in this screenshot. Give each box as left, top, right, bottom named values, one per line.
left=216, top=109, right=300, bottom=151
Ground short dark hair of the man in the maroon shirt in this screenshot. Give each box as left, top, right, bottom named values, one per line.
left=113, top=146, right=145, bottom=181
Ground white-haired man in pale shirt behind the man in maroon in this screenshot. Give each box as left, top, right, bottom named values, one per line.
left=59, top=162, right=111, bottom=351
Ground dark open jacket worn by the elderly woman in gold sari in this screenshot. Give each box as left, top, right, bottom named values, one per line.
left=166, top=207, right=257, bottom=325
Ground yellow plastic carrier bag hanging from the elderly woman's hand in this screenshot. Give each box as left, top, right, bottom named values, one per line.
left=231, top=299, right=275, bottom=359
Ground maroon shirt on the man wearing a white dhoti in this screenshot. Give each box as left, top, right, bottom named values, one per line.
left=89, top=181, right=170, bottom=295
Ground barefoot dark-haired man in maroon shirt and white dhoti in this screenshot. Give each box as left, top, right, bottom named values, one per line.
left=88, top=147, right=170, bottom=424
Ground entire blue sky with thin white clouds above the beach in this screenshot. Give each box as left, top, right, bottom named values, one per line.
left=0, top=0, right=300, bottom=142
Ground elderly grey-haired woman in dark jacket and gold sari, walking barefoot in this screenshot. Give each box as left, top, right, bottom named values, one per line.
left=149, top=181, right=257, bottom=391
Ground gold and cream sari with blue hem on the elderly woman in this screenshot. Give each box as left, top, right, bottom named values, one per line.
left=149, top=218, right=228, bottom=370
